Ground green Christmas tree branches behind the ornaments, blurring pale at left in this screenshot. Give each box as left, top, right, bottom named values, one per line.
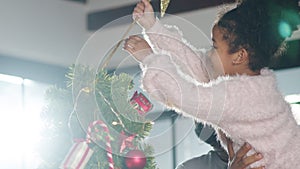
left=40, top=66, right=157, bottom=169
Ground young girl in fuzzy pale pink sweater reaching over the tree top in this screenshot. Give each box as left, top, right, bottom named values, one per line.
left=125, top=0, right=300, bottom=169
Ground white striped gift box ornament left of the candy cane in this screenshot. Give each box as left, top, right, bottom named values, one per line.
left=60, top=140, right=93, bottom=169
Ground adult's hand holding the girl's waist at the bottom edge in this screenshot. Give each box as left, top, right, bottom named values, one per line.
left=227, top=139, right=264, bottom=169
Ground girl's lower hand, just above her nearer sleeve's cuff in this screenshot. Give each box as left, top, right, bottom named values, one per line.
left=123, top=35, right=153, bottom=61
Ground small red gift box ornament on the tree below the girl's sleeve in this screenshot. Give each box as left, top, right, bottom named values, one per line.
left=130, top=91, right=153, bottom=115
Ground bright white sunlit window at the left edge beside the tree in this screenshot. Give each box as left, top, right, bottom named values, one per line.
left=0, top=74, right=49, bottom=169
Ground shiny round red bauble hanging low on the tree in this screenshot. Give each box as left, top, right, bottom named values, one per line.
left=125, top=150, right=147, bottom=169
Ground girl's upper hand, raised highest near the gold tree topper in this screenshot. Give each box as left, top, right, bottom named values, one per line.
left=132, top=0, right=156, bottom=29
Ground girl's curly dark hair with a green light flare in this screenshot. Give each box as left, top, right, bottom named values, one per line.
left=216, top=0, right=300, bottom=71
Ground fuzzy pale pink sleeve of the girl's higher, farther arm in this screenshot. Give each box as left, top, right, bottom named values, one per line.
left=144, top=20, right=209, bottom=82
